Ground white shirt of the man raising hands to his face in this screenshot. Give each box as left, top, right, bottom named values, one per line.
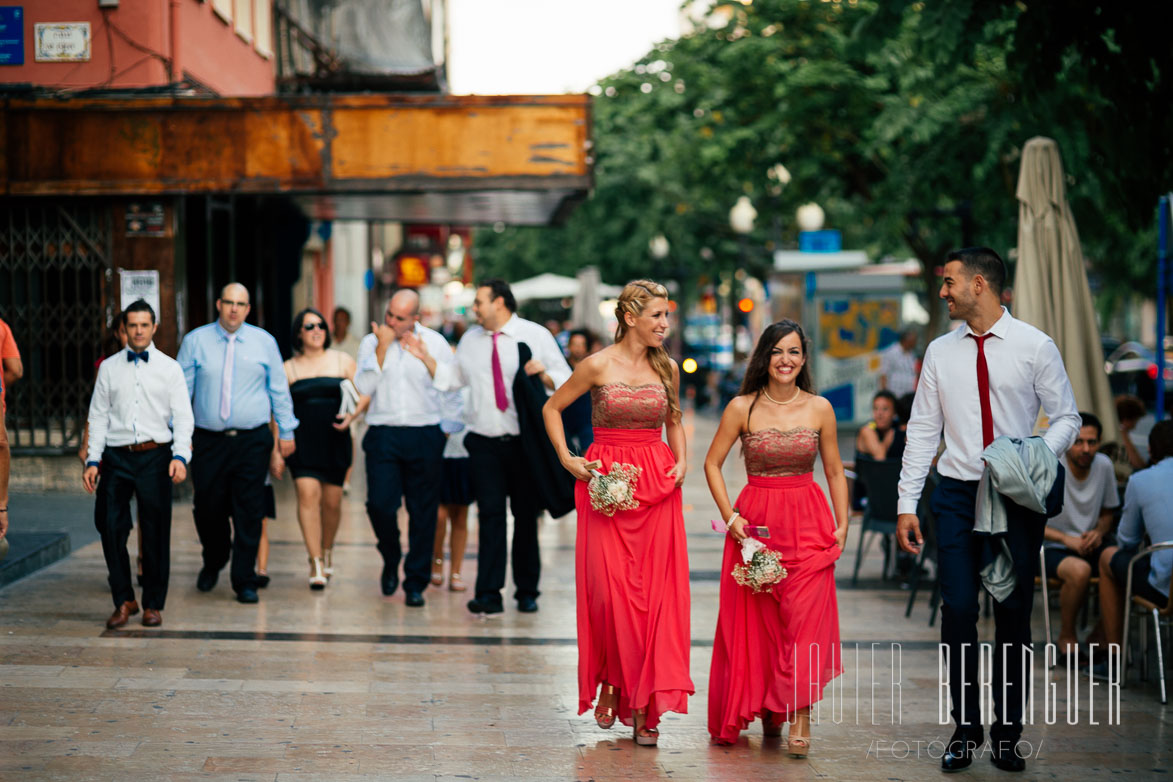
left=354, top=324, right=453, bottom=427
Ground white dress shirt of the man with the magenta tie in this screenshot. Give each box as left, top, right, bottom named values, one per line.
left=433, top=314, right=570, bottom=437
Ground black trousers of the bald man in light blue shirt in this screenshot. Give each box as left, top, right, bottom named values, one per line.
left=191, top=424, right=273, bottom=592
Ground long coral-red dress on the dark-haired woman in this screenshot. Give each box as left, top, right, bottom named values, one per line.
left=708, top=427, right=843, bottom=743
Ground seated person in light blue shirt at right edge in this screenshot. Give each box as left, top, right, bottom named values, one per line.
left=1099, top=421, right=1173, bottom=656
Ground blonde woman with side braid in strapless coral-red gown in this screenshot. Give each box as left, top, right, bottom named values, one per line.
left=543, top=280, right=693, bottom=746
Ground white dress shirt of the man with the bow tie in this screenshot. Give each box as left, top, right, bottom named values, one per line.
left=86, top=342, right=195, bottom=464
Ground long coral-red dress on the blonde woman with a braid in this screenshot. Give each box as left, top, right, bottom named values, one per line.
left=575, top=383, right=694, bottom=728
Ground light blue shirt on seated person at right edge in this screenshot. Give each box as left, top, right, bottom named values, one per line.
left=1116, top=456, right=1173, bottom=597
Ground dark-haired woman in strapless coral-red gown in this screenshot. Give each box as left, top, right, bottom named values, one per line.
left=705, top=320, right=848, bottom=757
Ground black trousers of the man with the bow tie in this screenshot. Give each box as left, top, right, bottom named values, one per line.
left=94, top=447, right=171, bottom=611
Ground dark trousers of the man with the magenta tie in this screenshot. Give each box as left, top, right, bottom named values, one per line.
left=465, top=433, right=542, bottom=603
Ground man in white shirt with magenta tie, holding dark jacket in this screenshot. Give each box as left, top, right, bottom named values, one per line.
left=405, top=279, right=570, bottom=614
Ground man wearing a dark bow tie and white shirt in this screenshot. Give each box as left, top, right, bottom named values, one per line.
left=82, top=299, right=195, bottom=630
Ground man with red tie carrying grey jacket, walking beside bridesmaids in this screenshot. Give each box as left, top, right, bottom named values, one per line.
left=896, top=247, right=1080, bottom=771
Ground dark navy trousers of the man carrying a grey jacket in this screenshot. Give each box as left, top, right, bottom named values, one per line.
left=930, top=478, right=1063, bottom=742
